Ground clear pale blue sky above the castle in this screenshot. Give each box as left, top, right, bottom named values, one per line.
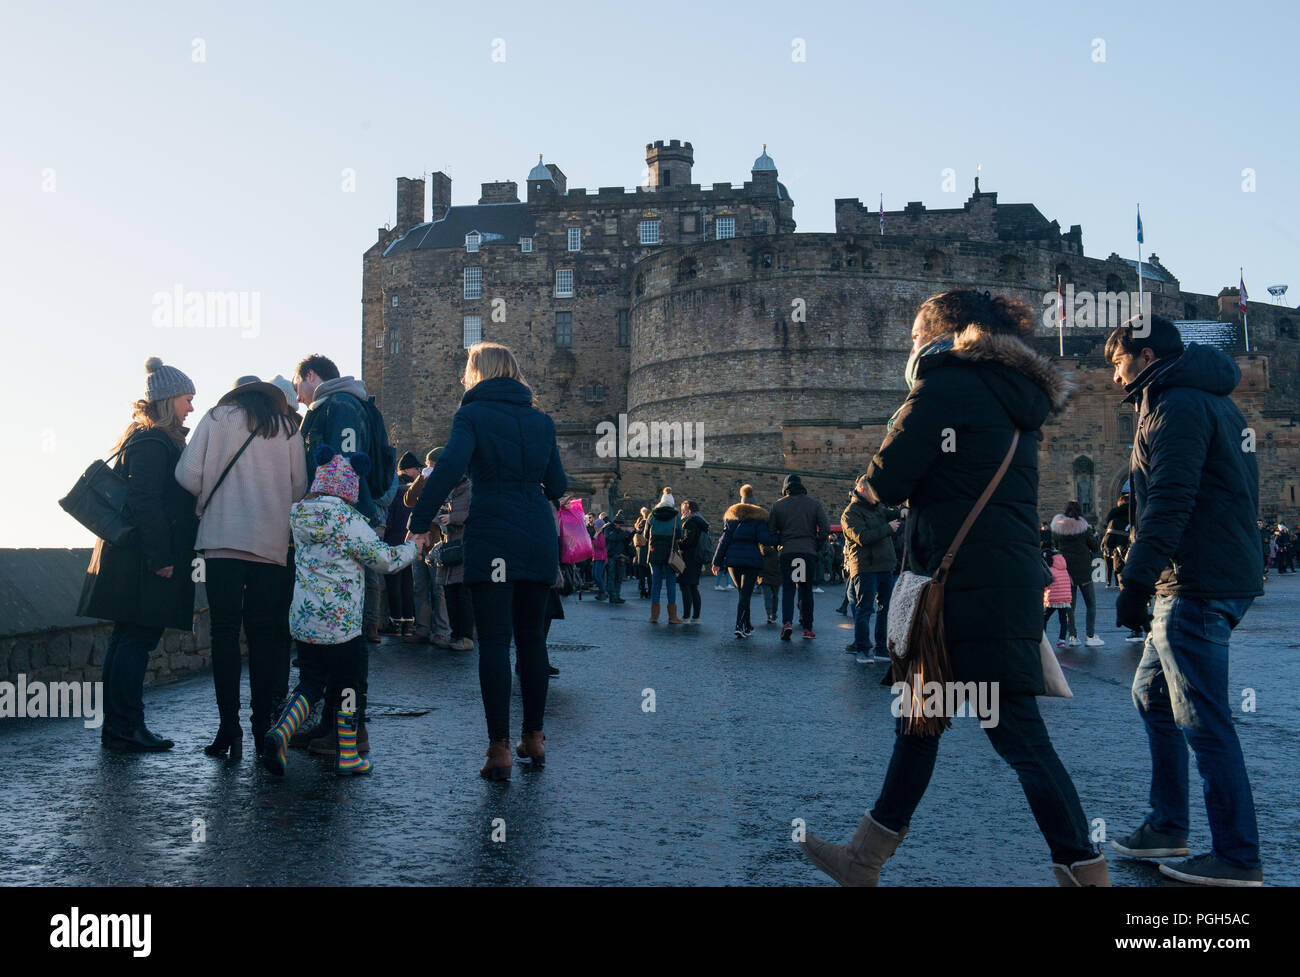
left=0, top=0, right=1300, bottom=547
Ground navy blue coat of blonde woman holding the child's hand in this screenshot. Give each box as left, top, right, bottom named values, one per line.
left=411, top=377, right=568, bottom=583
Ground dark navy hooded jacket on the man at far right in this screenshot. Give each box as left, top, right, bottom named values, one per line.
left=1122, top=343, right=1264, bottom=600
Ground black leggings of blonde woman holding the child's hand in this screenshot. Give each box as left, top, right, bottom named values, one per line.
left=468, top=581, right=551, bottom=741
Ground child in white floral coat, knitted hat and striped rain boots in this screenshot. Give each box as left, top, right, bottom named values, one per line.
left=263, top=446, right=419, bottom=777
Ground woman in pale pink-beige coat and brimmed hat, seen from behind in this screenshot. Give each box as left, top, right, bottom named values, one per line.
left=176, top=378, right=307, bottom=759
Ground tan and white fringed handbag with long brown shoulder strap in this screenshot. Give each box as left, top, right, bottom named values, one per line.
left=887, top=430, right=1021, bottom=737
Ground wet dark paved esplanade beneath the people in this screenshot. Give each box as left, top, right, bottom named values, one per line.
left=0, top=576, right=1300, bottom=886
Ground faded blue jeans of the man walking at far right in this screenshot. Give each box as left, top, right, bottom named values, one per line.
left=1132, top=596, right=1260, bottom=868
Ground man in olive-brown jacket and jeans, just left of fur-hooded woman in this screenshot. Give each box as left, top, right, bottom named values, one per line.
left=840, top=474, right=902, bottom=665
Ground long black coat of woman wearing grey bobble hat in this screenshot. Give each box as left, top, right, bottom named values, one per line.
left=77, top=430, right=199, bottom=631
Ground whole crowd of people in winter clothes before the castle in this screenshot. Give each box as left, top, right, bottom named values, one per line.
left=73, top=290, right=1268, bottom=886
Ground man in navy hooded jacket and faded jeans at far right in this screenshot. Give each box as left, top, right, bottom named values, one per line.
left=1106, top=316, right=1264, bottom=886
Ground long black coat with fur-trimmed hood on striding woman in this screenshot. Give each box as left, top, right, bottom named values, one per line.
left=867, top=327, right=1069, bottom=695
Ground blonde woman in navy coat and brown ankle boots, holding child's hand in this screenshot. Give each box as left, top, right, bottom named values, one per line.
left=411, top=343, right=568, bottom=781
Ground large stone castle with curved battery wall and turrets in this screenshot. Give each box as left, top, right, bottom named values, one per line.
left=361, top=139, right=1300, bottom=525
